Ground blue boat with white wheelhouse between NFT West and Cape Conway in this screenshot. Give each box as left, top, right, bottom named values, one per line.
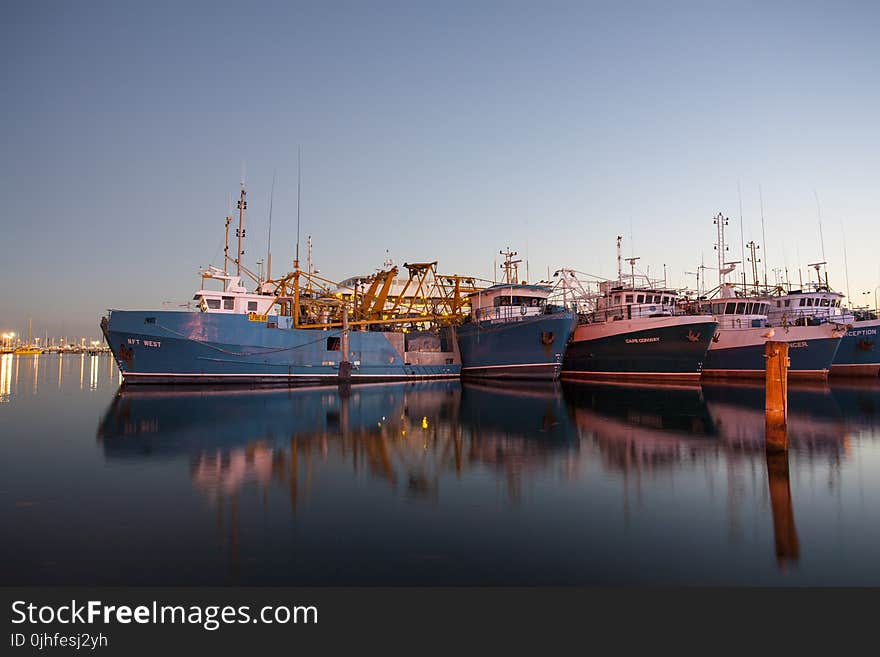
left=457, top=250, right=574, bottom=380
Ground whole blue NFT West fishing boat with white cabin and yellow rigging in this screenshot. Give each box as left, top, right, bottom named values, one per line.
left=101, top=185, right=469, bottom=385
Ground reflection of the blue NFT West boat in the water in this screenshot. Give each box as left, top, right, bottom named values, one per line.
left=98, top=382, right=461, bottom=506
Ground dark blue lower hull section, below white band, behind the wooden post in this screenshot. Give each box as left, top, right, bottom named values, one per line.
left=703, top=338, right=841, bottom=377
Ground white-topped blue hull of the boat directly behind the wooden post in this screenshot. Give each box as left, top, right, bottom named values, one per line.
left=703, top=324, right=841, bottom=380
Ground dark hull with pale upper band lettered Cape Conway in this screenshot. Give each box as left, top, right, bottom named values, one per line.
left=562, top=315, right=718, bottom=381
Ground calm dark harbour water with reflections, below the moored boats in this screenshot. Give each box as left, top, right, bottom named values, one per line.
left=0, top=355, right=880, bottom=586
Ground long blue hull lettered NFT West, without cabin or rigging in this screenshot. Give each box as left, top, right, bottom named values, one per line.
left=105, top=310, right=461, bottom=385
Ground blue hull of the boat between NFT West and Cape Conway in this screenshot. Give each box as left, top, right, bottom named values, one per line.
left=458, top=312, right=574, bottom=380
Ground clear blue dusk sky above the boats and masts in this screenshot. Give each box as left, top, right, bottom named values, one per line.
left=0, top=1, right=880, bottom=335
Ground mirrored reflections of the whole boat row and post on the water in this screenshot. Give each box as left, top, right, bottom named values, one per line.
left=97, top=374, right=880, bottom=571
